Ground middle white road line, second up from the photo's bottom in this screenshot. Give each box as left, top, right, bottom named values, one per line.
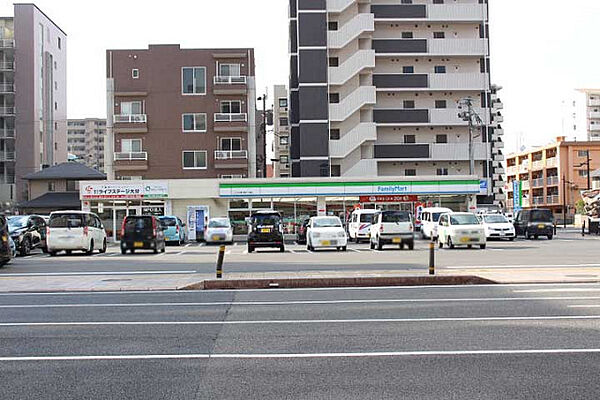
left=0, top=315, right=600, bottom=328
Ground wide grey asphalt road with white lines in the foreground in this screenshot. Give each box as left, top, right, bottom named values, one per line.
left=0, top=284, right=600, bottom=400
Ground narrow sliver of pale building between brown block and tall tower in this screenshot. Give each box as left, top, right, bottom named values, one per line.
left=273, top=85, right=291, bottom=178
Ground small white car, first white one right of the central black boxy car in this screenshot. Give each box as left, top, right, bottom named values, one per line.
left=306, top=217, right=348, bottom=251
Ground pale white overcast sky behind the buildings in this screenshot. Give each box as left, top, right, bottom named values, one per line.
left=0, top=0, right=600, bottom=155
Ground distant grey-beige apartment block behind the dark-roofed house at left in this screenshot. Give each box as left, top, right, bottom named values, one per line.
left=67, top=118, right=106, bottom=171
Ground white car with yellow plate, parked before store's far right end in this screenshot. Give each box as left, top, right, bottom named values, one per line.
left=438, top=213, right=486, bottom=249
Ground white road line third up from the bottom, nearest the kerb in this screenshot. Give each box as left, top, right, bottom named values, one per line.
left=0, top=296, right=600, bottom=309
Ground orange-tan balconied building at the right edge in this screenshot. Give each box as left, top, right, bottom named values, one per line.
left=506, top=136, right=600, bottom=217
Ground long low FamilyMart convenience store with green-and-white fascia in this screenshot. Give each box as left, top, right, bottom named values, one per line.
left=80, top=176, right=481, bottom=240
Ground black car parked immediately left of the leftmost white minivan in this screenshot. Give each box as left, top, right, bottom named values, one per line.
left=8, top=215, right=47, bottom=256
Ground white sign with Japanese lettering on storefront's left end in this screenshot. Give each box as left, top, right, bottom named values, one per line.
left=79, top=181, right=169, bottom=200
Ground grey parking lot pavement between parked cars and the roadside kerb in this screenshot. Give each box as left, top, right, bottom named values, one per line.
left=0, top=233, right=600, bottom=276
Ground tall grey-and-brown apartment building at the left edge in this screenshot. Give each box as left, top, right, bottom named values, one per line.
left=0, top=4, right=67, bottom=203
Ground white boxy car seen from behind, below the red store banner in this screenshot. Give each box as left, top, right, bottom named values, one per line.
left=371, top=211, right=415, bottom=250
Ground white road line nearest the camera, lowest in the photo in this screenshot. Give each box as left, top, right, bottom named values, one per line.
left=0, top=349, right=600, bottom=362
